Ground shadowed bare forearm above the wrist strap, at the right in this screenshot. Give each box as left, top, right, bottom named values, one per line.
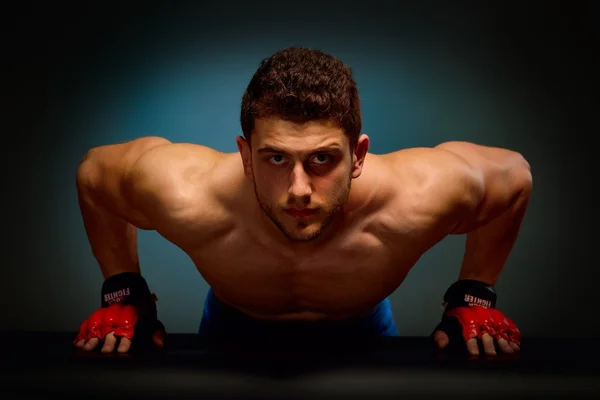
left=459, top=179, right=531, bottom=285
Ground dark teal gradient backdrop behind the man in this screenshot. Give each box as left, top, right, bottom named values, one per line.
left=0, top=2, right=600, bottom=336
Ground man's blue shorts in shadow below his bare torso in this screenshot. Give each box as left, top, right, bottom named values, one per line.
left=198, top=289, right=398, bottom=340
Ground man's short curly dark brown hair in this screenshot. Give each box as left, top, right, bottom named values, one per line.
left=240, top=47, right=362, bottom=149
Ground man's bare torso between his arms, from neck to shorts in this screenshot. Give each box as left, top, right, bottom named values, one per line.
left=154, top=145, right=454, bottom=320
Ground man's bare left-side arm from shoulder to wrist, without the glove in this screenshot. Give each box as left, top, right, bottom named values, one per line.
left=77, top=137, right=220, bottom=279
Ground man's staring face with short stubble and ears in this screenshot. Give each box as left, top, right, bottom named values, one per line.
left=238, top=118, right=368, bottom=241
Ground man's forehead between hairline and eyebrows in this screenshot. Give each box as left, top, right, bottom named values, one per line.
left=252, top=118, right=348, bottom=151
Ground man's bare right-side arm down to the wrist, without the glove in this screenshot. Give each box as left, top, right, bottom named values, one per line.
left=436, top=142, right=532, bottom=285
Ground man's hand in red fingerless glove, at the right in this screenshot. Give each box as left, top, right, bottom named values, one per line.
left=433, top=306, right=521, bottom=356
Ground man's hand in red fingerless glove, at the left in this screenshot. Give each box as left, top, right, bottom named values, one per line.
left=73, top=303, right=166, bottom=353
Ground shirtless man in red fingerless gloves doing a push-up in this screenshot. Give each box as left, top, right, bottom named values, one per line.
left=74, top=48, right=532, bottom=355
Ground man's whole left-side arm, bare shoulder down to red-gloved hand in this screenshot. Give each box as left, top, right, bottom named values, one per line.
left=74, top=137, right=224, bottom=353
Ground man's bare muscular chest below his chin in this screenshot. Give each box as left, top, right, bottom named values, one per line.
left=193, top=217, right=418, bottom=309
